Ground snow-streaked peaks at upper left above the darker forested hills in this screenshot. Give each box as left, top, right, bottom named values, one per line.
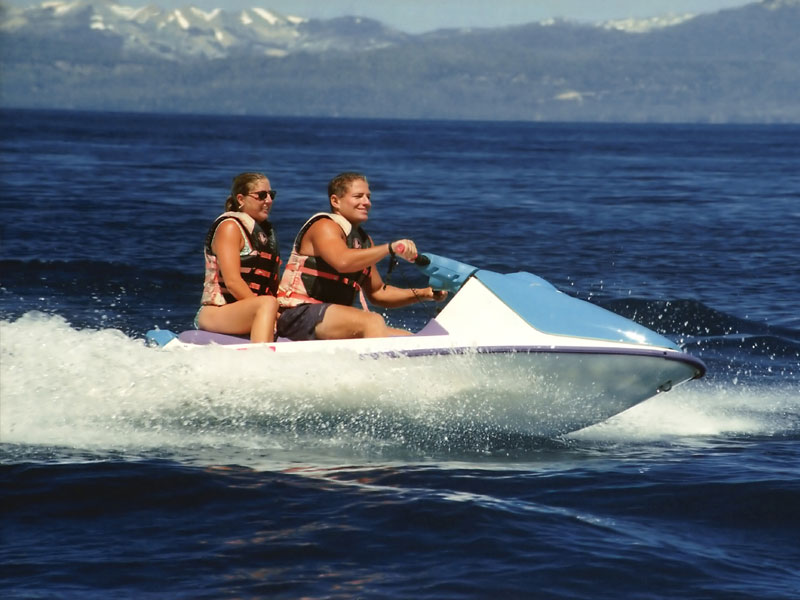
left=0, top=0, right=406, bottom=60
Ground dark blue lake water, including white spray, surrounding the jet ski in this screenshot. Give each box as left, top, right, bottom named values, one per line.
left=0, top=111, right=800, bottom=599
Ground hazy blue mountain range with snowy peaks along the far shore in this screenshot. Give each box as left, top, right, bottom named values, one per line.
left=0, top=0, right=800, bottom=123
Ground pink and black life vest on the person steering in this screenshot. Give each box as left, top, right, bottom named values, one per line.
left=278, top=213, right=372, bottom=309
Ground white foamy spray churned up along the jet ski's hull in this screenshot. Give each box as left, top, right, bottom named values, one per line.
left=0, top=313, right=800, bottom=466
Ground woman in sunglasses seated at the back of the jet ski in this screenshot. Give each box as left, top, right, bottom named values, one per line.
left=195, top=173, right=281, bottom=342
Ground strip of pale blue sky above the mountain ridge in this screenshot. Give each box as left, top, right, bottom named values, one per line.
left=7, top=0, right=756, bottom=33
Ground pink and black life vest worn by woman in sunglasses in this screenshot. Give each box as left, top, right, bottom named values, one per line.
left=201, top=211, right=281, bottom=306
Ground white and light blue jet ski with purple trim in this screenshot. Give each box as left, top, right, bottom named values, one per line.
left=146, top=253, right=706, bottom=434
